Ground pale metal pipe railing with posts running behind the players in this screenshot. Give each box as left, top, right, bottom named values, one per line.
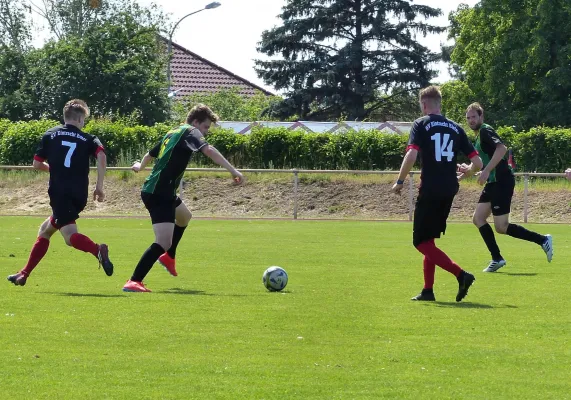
left=0, top=165, right=565, bottom=222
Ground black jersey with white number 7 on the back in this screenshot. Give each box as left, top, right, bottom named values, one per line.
left=34, top=125, right=104, bottom=196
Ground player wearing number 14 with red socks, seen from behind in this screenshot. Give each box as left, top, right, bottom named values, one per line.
left=392, top=86, right=482, bottom=301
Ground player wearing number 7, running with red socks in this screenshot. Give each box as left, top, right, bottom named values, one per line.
left=8, top=99, right=113, bottom=286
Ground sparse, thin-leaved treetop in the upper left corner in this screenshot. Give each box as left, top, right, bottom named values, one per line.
left=0, top=0, right=31, bottom=51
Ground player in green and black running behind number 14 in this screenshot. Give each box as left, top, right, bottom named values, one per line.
left=458, top=103, right=553, bottom=272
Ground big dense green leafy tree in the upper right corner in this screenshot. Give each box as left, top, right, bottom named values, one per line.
left=449, top=0, right=571, bottom=129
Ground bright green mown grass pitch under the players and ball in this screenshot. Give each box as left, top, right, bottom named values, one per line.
left=0, top=217, right=571, bottom=400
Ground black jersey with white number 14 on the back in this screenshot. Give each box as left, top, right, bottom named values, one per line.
left=407, top=114, right=478, bottom=196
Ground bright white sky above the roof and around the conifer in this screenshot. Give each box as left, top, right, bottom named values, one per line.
left=32, top=0, right=478, bottom=91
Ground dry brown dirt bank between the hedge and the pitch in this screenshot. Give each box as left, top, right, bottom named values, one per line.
left=0, top=174, right=571, bottom=223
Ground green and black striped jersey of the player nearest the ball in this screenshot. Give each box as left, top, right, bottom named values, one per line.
left=142, top=125, right=208, bottom=197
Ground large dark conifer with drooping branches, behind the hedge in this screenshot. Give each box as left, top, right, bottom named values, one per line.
left=256, top=0, right=443, bottom=120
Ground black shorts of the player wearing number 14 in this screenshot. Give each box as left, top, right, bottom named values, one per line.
left=412, top=193, right=454, bottom=247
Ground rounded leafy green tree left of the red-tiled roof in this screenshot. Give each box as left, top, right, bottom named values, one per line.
left=15, top=13, right=168, bottom=124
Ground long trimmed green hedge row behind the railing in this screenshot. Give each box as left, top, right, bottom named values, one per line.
left=0, top=120, right=571, bottom=172
